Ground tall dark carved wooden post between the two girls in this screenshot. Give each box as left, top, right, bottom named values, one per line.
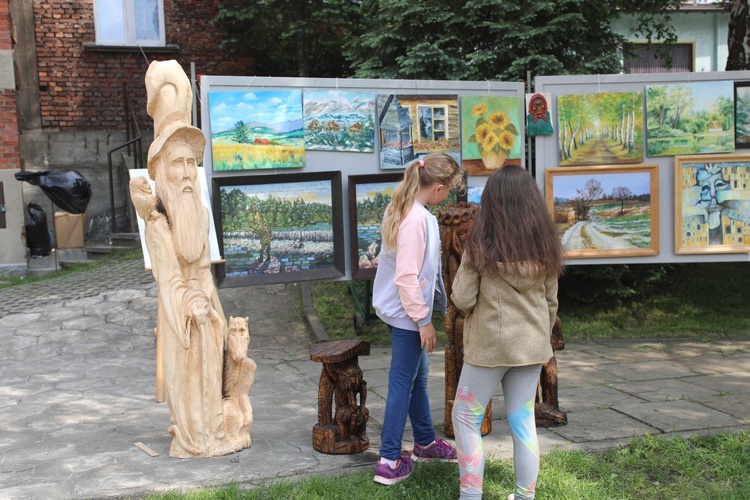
left=438, top=202, right=492, bottom=437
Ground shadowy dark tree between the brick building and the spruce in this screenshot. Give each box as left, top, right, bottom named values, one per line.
left=212, top=0, right=362, bottom=77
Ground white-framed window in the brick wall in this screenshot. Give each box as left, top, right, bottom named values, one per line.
left=94, top=0, right=165, bottom=47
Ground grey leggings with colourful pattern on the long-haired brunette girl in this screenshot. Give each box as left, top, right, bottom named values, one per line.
left=452, top=363, right=542, bottom=500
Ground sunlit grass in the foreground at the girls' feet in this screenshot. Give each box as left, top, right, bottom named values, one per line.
left=148, top=432, right=750, bottom=500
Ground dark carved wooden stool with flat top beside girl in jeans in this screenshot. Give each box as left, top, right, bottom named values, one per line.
left=310, top=339, right=370, bottom=454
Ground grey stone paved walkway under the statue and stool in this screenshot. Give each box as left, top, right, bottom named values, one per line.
left=0, top=261, right=750, bottom=499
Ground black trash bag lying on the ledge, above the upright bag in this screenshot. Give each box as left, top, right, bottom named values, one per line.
left=15, top=170, right=91, bottom=214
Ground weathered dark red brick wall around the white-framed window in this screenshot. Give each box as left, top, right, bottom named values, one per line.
left=34, top=0, right=252, bottom=131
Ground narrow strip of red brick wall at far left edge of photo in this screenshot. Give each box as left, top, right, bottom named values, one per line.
left=0, top=0, right=21, bottom=169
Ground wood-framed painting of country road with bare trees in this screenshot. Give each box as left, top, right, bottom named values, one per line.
left=545, top=165, right=659, bottom=258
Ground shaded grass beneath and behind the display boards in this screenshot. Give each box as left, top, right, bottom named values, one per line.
left=311, top=262, right=750, bottom=345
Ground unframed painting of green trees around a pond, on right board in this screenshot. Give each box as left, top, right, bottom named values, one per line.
left=646, top=81, right=735, bottom=156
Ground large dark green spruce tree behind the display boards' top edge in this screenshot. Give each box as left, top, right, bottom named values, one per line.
left=346, top=0, right=680, bottom=81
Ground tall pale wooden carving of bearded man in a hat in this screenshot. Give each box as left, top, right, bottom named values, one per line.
left=130, top=61, right=254, bottom=458
